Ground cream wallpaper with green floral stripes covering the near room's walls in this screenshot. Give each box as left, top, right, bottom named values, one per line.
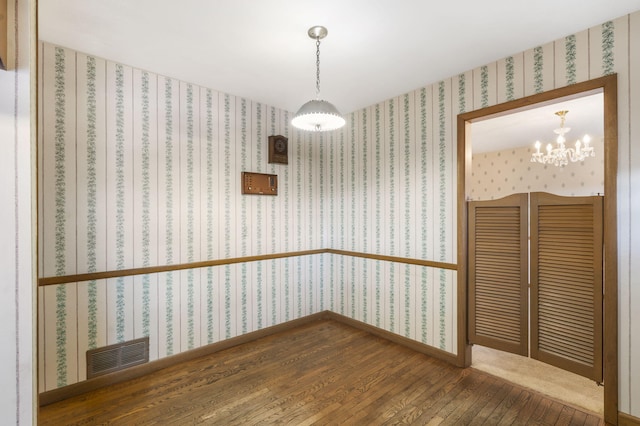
left=39, top=13, right=640, bottom=415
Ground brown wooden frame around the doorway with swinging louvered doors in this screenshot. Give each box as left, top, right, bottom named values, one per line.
left=457, top=74, right=618, bottom=424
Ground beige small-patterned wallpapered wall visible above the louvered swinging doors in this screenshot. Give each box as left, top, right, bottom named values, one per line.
left=468, top=140, right=604, bottom=201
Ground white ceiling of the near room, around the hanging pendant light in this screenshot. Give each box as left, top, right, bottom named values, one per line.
left=39, top=0, right=640, bottom=113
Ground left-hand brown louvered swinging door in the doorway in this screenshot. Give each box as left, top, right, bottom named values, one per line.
left=469, top=194, right=528, bottom=356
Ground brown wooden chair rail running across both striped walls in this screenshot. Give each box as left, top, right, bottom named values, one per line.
left=38, top=249, right=458, bottom=287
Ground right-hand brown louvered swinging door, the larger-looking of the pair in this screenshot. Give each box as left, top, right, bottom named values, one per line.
left=531, top=192, right=602, bottom=382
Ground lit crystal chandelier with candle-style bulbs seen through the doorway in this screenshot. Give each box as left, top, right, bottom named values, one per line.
left=531, top=111, right=596, bottom=167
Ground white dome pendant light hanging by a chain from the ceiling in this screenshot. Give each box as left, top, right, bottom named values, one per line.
left=291, top=26, right=345, bottom=132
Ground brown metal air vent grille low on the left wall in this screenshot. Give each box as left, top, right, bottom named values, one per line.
left=87, top=337, right=149, bottom=379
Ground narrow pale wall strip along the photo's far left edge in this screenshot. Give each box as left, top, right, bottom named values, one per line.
left=0, top=1, right=35, bottom=425
